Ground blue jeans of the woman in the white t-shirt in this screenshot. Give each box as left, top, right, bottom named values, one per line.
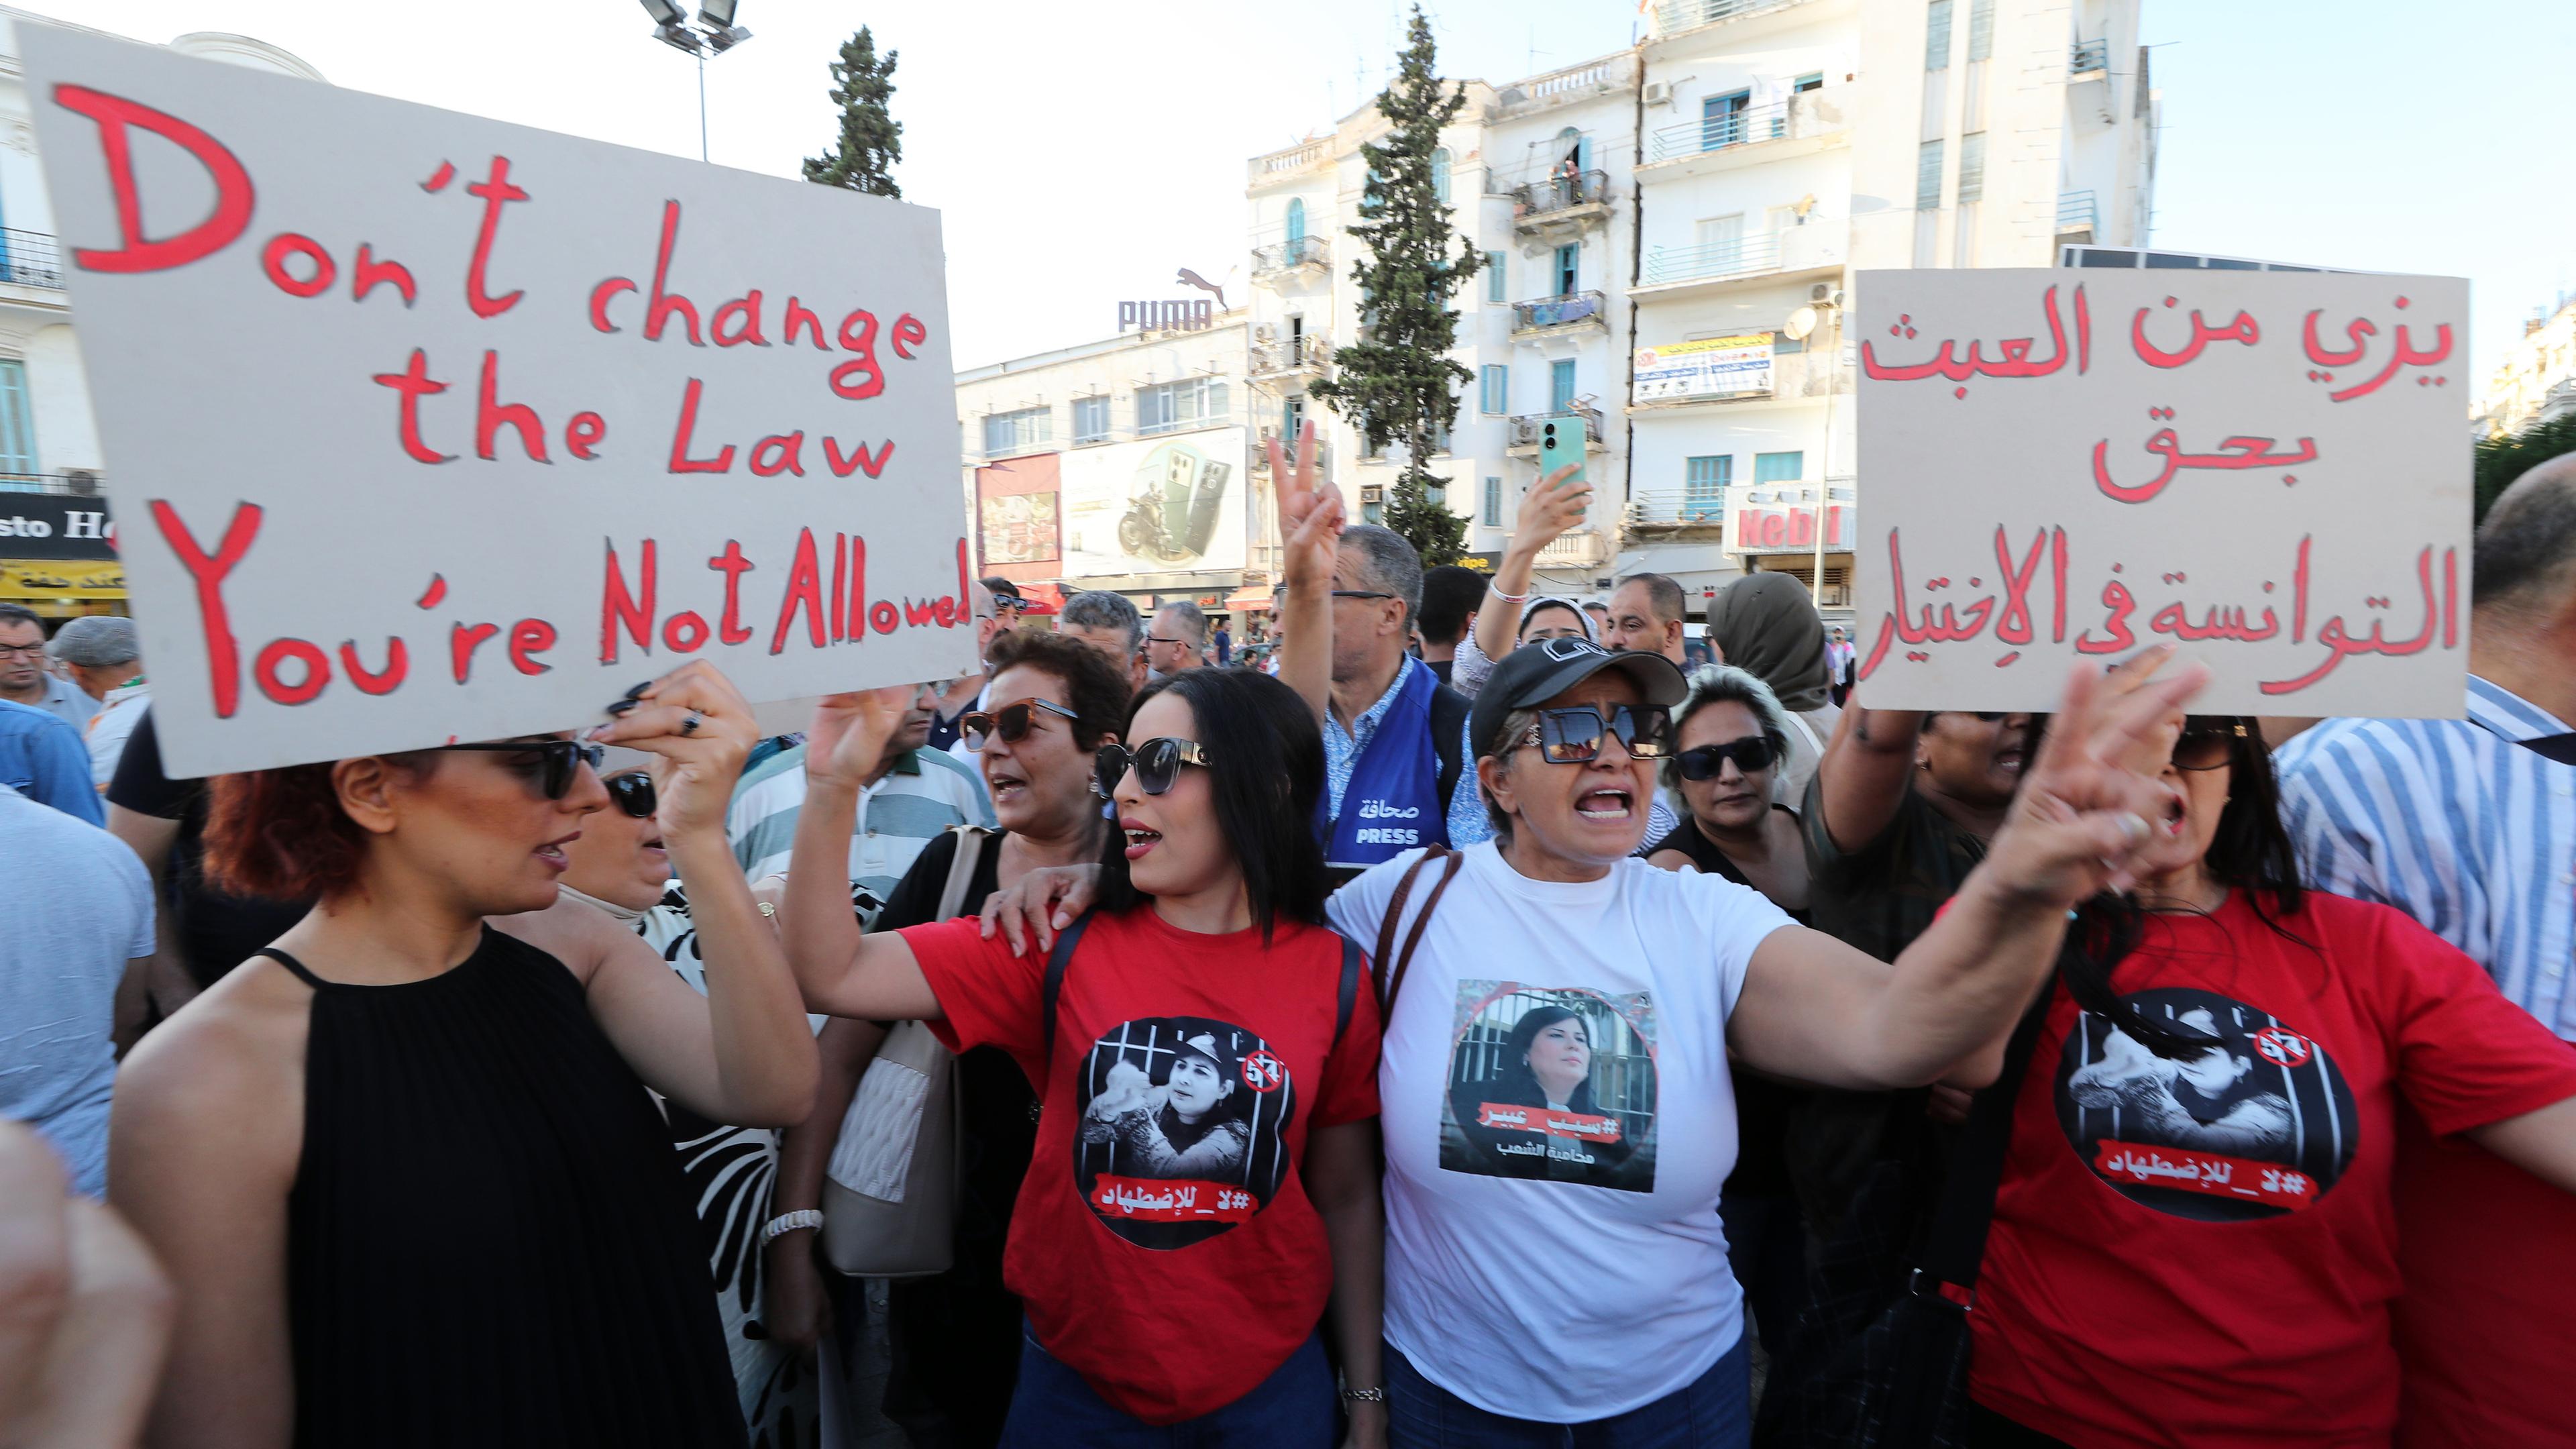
left=1386, top=1338, right=1754, bottom=1449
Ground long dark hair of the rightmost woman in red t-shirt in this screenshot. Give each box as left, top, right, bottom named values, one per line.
left=2058, top=714, right=2316, bottom=1060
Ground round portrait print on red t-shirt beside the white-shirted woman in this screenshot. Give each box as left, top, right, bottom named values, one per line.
left=1074, top=1016, right=1296, bottom=1248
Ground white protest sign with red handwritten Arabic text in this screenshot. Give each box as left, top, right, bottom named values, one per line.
left=1855, top=271, right=2471, bottom=719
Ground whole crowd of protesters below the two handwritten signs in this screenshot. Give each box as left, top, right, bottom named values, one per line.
left=0, top=430, right=2576, bottom=1449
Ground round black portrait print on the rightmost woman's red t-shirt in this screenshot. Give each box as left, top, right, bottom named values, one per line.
left=2055, top=987, right=2359, bottom=1222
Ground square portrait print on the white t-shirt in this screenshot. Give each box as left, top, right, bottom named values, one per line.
left=1440, top=979, right=1654, bottom=1191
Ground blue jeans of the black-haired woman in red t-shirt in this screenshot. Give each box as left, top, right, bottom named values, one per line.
left=1002, top=1333, right=1337, bottom=1449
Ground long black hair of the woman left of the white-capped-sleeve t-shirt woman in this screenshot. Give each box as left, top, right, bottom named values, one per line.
left=1097, top=670, right=1329, bottom=944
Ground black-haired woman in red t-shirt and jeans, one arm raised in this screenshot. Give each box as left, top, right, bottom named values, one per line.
left=781, top=670, right=1386, bottom=1449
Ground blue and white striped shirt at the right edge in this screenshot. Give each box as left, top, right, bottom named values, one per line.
left=2275, top=676, right=2576, bottom=1042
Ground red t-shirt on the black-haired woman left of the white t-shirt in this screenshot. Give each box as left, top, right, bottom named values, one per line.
left=902, top=905, right=1378, bottom=1424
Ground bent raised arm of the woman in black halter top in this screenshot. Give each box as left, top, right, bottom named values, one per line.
left=585, top=660, right=816, bottom=1127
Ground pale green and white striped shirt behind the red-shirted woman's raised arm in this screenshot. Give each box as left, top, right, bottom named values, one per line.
left=724, top=681, right=994, bottom=928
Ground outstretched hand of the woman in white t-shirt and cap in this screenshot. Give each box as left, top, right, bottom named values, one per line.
left=1984, top=655, right=2210, bottom=910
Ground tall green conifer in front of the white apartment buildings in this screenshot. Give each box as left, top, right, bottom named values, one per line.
left=1306, top=5, right=1484, bottom=565
